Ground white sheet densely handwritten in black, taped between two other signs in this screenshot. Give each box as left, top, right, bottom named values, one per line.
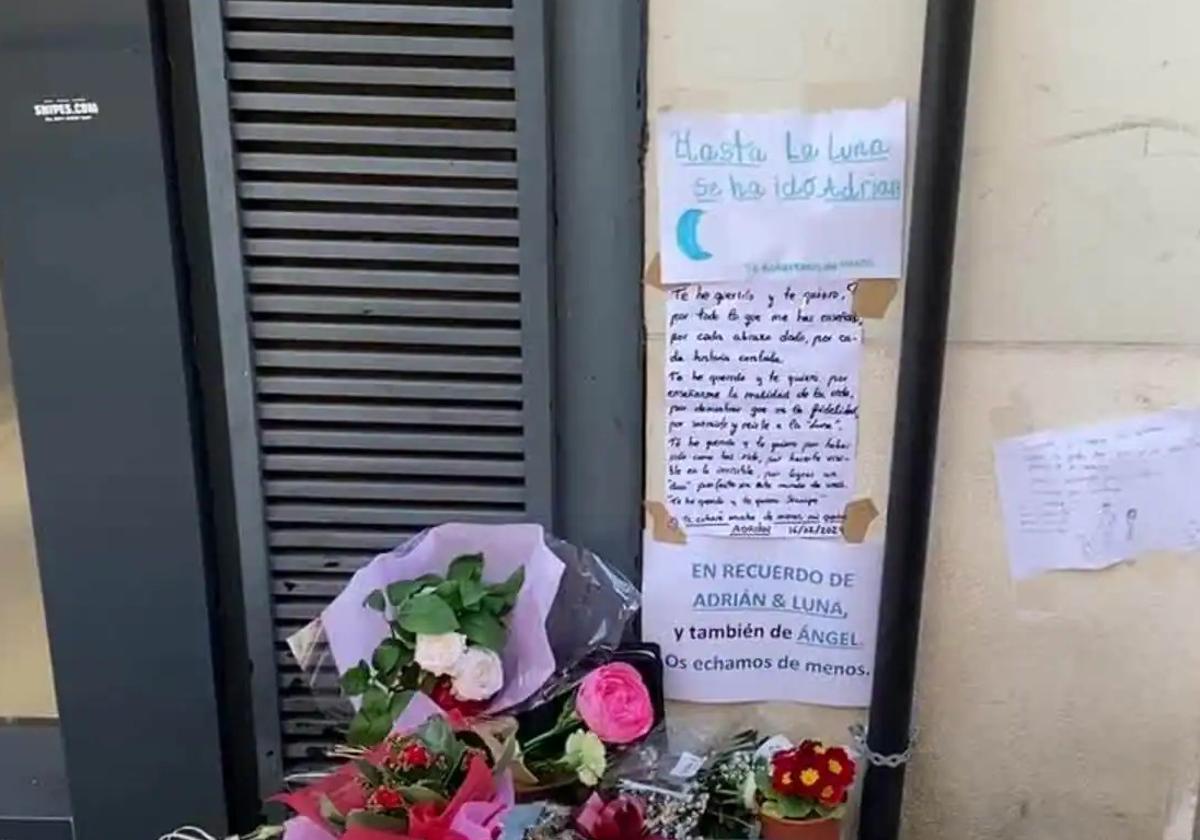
left=665, top=282, right=863, bottom=536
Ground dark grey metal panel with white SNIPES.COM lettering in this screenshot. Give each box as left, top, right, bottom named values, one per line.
left=0, top=0, right=226, bottom=840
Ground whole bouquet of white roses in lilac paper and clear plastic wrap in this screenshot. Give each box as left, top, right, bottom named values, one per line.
left=288, top=523, right=638, bottom=745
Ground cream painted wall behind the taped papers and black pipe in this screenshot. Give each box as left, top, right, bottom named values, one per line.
left=646, top=0, right=1200, bottom=840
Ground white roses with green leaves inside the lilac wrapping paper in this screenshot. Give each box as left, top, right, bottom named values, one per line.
left=342, top=553, right=524, bottom=745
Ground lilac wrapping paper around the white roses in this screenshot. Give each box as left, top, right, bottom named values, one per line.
left=320, top=523, right=564, bottom=714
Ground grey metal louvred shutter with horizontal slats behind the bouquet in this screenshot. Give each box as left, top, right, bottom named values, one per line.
left=193, top=0, right=552, bottom=788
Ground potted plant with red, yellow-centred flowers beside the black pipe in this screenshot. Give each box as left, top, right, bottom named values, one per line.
left=755, top=740, right=856, bottom=840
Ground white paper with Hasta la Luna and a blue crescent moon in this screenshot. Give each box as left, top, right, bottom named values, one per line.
left=658, top=101, right=906, bottom=283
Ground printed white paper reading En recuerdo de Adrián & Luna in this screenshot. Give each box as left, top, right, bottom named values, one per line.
left=642, top=536, right=883, bottom=707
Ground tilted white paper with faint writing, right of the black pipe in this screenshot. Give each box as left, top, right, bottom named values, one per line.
left=996, top=410, right=1200, bottom=578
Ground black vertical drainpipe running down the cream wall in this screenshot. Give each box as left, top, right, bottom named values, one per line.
left=858, top=0, right=974, bottom=840
